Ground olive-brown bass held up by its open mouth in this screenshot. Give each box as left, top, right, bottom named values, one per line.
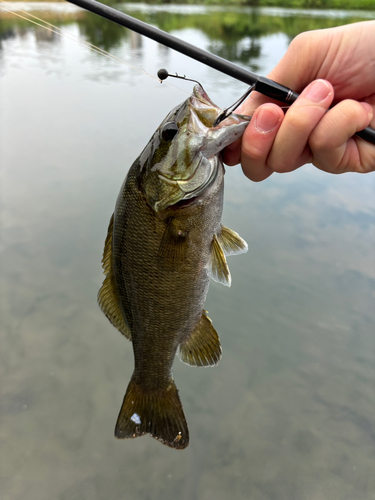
left=98, top=85, right=248, bottom=449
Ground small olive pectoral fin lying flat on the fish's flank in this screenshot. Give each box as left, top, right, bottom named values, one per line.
left=158, top=219, right=189, bottom=271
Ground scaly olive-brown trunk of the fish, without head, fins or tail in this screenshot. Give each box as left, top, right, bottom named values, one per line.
left=113, top=158, right=223, bottom=384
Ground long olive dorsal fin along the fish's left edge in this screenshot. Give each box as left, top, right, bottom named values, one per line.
left=98, top=215, right=131, bottom=340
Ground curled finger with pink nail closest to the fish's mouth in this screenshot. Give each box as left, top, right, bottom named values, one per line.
left=241, top=103, right=284, bottom=182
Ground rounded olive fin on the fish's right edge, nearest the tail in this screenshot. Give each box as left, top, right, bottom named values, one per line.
left=178, top=311, right=221, bottom=366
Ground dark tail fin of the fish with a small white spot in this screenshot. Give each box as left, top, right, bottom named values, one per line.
left=115, top=378, right=189, bottom=449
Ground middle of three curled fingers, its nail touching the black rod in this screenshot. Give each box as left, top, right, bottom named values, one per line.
left=268, top=80, right=334, bottom=172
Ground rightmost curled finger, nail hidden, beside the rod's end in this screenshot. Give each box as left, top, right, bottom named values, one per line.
left=309, top=99, right=375, bottom=173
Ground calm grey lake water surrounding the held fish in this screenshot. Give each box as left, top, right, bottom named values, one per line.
left=0, top=3, right=375, bottom=500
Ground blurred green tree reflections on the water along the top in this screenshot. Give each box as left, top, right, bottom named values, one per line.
left=0, top=4, right=370, bottom=66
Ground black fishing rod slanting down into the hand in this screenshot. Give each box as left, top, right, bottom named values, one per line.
left=67, top=0, right=375, bottom=144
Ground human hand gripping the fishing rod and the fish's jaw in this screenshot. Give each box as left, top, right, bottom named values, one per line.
left=223, top=21, right=375, bottom=181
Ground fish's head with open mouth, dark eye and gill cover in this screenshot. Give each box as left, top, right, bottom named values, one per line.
left=139, top=85, right=248, bottom=212
